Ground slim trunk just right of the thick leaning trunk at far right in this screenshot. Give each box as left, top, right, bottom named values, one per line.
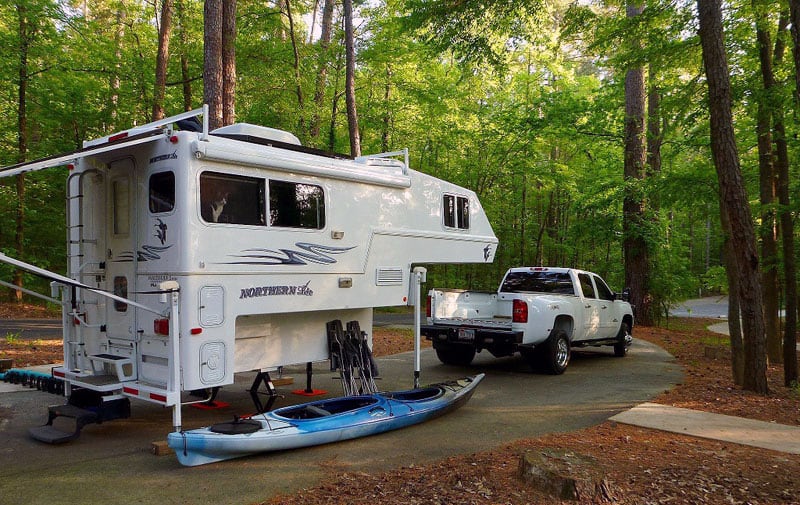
left=753, top=6, right=782, bottom=363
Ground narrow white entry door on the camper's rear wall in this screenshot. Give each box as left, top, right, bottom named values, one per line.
left=105, top=158, right=137, bottom=340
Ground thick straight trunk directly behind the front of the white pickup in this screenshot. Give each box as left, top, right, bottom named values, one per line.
left=622, top=0, right=653, bottom=325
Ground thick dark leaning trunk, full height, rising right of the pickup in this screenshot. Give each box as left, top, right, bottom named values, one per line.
left=697, top=0, right=769, bottom=394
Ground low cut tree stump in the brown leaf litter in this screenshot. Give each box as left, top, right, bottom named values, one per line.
left=519, top=449, right=613, bottom=502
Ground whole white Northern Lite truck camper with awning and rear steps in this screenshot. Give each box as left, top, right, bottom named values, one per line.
left=0, top=108, right=497, bottom=443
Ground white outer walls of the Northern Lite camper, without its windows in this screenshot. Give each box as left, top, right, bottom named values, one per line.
left=57, top=123, right=497, bottom=390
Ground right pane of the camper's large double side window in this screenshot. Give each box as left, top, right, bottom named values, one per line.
left=269, top=180, right=325, bottom=230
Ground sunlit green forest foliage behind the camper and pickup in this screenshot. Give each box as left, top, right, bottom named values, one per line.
left=0, top=0, right=788, bottom=310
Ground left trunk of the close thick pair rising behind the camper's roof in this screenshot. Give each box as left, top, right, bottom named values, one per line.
left=203, top=0, right=224, bottom=130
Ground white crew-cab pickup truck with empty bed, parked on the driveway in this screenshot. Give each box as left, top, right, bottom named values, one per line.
left=420, top=267, right=633, bottom=375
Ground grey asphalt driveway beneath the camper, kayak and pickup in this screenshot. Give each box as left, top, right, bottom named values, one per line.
left=0, top=341, right=682, bottom=505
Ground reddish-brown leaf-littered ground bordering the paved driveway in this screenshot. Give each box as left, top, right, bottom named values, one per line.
left=0, top=308, right=800, bottom=505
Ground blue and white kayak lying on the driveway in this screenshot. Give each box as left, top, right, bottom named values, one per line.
left=167, top=374, right=484, bottom=466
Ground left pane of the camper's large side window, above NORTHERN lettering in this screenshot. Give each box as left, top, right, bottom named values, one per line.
left=200, top=172, right=266, bottom=226
